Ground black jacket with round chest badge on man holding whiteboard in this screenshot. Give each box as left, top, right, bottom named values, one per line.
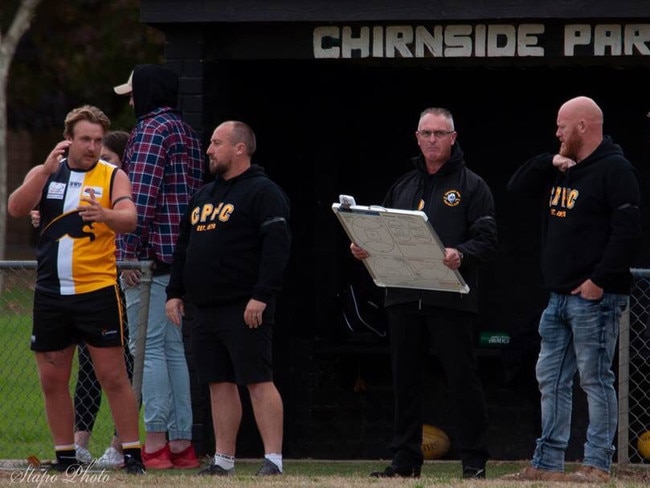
left=383, top=143, right=497, bottom=313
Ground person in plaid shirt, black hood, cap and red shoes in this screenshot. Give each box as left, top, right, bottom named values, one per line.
left=114, top=64, right=205, bottom=469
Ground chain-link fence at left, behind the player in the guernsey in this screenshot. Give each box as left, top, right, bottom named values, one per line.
left=0, top=261, right=151, bottom=459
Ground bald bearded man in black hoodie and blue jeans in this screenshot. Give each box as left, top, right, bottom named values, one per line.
left=508, top=96, right=641, bottom=483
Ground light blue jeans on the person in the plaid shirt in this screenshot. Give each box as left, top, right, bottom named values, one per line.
left=125, top=275, right=192, bottom=441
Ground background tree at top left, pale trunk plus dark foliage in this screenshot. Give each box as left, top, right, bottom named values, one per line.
left=0, top=0, right=164, bottom=259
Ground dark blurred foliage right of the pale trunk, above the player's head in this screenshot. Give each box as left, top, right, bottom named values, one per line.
left=7, top=0, right=164, bottom=130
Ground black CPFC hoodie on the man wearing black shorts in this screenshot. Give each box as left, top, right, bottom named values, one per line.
left=167, top=164, right=291, bottom=314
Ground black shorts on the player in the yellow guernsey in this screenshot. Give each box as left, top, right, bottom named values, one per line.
left=31, top=283, right=126, bottom=352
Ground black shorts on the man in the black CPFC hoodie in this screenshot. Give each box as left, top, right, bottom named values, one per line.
left=191, top=302, right=273, bottom=385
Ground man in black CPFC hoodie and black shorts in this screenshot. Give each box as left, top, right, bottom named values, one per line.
left=165, top=120, right=291, bottom=476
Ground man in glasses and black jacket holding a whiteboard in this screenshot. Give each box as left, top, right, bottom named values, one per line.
left=350, top=108, right=497, bottom=479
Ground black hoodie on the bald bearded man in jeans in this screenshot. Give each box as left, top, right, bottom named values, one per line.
left=508, top=136, right=641, bottom=294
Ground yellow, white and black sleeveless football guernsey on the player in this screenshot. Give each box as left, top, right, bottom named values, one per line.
left=36, top=159, right=117, bottom=295
